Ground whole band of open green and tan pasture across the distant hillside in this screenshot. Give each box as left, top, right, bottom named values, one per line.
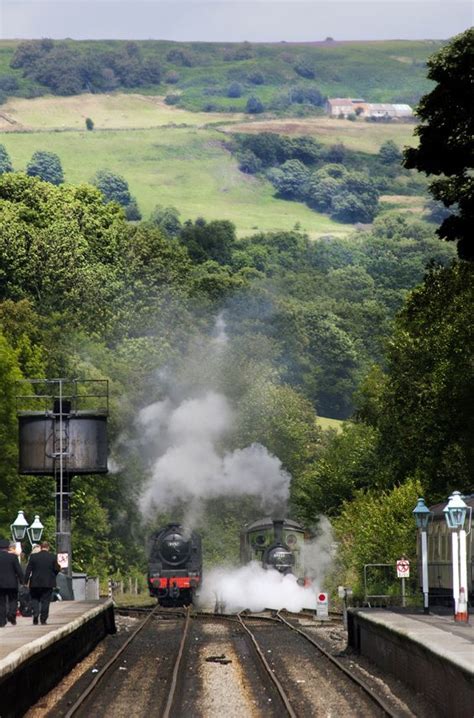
left=0, top=88, right=420, bottom=232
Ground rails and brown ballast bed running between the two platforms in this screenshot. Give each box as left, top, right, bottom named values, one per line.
left=49, top=606, right=408, bottom=718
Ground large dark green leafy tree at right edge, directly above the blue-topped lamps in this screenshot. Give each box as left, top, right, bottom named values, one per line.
left=359, top=262, right=474, bottom=500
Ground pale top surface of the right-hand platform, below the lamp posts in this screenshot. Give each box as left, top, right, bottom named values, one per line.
left=357, top=608, right=474, bottom=676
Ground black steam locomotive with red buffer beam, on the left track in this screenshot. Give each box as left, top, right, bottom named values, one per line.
left=148, top=523, right=202, bottom=606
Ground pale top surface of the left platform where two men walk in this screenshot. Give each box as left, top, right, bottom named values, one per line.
left=0, top=598, right=112, bottom=678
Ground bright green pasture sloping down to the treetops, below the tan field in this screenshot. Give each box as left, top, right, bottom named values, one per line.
left=0, top=127, right=351, bottom=237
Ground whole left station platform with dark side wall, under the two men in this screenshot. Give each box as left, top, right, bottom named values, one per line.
left=0, top=599, right=115, bottom=718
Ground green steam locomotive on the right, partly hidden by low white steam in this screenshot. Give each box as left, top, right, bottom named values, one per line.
left=240, top=518, right=306, bottom=585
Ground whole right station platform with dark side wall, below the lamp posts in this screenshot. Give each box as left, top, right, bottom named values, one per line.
left=348, top=608, right=474, bottom=718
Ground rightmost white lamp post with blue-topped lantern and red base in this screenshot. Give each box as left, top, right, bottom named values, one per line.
left=443, top=491, right=472, bottom=623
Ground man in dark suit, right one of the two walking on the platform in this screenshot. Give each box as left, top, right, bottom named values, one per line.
left=25, top=541, right=60, bottom=626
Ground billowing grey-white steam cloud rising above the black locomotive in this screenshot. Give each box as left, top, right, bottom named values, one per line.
left=138, top=391, right=290, bottom=511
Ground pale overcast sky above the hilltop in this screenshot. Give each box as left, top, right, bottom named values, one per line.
left=0, top=0, right=474, bottom=42
